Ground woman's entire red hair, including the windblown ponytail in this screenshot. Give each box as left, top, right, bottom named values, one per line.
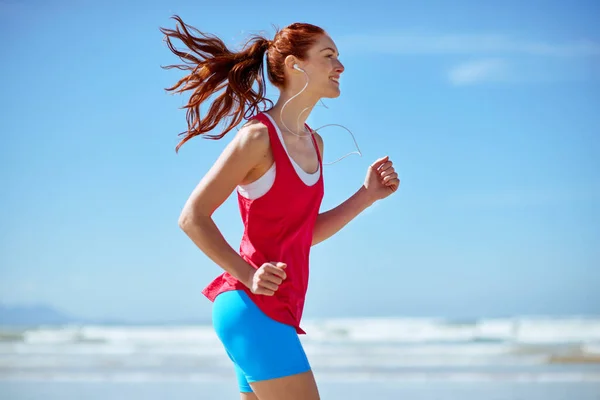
left=160, top=16, right=325, bottom=151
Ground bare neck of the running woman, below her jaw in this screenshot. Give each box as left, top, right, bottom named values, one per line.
left=269, top=87, right=319, bottom=136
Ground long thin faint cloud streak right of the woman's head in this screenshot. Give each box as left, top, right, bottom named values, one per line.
left=336, top=32, right=600, bottom=57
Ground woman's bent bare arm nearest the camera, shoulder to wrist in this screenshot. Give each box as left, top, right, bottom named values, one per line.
left=179, top=123, right=270, bottom=288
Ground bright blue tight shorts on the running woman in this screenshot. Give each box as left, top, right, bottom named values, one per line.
left=212, top=290, right=310, bottom=392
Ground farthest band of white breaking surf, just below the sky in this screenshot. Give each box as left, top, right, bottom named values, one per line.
left=9, top=318, right=600, bottom=345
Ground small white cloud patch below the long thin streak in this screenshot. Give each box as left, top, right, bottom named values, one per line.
left=448, top=59, right=507, bottom=85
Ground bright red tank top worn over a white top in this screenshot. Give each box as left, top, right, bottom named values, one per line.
left=202, top=113, right=324, bottom=334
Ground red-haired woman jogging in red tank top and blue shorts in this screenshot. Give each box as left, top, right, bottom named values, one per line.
left=161, top=16, right=400, bottom=400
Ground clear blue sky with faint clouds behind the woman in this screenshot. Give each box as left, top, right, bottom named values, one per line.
left=0, top=0, right=600, bottom=321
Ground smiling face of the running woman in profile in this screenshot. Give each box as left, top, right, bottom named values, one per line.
left=298, top=34, right=344, bottom=98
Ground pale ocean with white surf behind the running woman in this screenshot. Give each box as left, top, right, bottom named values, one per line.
left=0, top=316, right=600, bottom=400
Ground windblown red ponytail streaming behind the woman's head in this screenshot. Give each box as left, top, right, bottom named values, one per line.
left=160, top=16, right=273, bottom=152
